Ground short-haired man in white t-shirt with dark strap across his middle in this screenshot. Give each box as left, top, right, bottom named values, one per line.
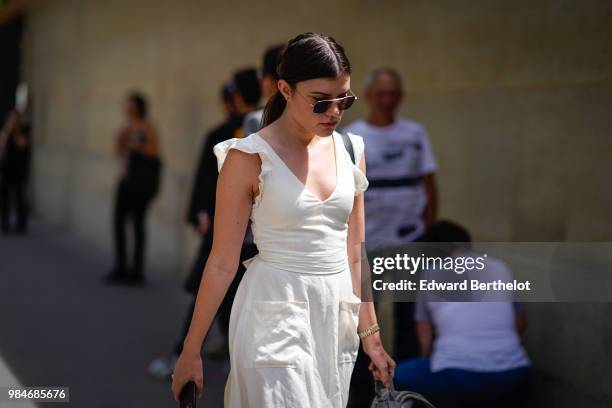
left=344, top=68, right=437, bottom=245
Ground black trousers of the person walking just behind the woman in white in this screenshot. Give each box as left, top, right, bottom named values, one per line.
left=174, top=241, right=257, bottom=354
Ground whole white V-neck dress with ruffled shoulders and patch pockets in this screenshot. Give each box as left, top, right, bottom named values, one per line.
left=214, top=132, right=368, bottom=408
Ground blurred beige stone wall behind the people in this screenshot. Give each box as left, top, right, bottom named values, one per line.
left=15, top=0, right=612, bottom=407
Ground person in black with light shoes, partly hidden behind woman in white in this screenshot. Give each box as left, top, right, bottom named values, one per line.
left=149, top=69, right=261, bottom=379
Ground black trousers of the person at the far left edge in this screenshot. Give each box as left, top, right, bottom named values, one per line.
left=0, top=175, right=28, bottom=232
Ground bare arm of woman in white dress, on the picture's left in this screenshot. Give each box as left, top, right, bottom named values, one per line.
left=172, top=149, right=261, bottom=400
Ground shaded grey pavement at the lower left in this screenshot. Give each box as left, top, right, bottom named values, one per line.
left=0, top=226, right=229, bottom=408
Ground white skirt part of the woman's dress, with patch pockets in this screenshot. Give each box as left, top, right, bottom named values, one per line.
left=224, top=256, right=361, bottom=408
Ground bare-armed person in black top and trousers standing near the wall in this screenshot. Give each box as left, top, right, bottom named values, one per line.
left=106, top=92, right=161, bottom=285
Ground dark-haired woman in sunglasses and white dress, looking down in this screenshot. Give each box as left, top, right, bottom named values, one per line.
left=172, top=33, right=395, bottom=408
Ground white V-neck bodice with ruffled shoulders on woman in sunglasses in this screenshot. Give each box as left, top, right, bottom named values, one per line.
left=213, top=132, right=368, bottom=274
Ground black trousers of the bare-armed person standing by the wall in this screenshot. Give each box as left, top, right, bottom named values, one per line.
left=113, top=179, right=153, bottom=275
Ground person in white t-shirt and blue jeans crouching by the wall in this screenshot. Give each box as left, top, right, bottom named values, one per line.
left=394, top=221, right=531, bottom=408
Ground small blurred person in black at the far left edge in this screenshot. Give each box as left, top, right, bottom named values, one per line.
left=0, top=110, right=31, bottom=234
